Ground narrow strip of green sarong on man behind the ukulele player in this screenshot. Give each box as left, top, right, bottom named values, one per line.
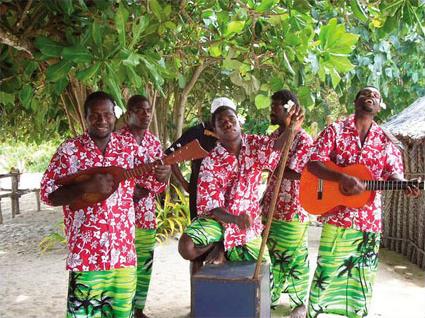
left=134, top=228, right=156, bottom=311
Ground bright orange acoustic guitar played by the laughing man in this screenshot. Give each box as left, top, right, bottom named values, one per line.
left=300, top=161, right=424, bottom=215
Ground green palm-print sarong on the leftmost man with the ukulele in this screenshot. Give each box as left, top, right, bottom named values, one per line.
left=67, top=267, right=136, bottom=318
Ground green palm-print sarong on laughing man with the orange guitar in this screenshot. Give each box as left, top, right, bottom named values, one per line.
left=308, top=224, right=380, bottom=318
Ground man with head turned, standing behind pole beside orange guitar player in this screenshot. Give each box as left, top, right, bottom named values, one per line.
left=263, top=90, right=313, bottom=317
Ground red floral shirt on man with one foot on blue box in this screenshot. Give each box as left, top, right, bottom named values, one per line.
left=197, top=134, right=280, bottom=250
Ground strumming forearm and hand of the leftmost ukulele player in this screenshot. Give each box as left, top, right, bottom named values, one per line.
left=49, top=174, right=114, bottom=206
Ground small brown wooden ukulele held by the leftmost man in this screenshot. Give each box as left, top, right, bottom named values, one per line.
left=55, top=140, right=208, bottom=210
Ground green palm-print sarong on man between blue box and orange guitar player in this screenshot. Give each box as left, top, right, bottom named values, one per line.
left=267, top=220, right=309, bottom=308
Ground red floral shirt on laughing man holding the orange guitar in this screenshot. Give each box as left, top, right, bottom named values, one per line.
left=311, top=115, right=403, bottom=233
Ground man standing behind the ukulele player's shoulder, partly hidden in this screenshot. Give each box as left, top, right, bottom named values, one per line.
left=118, top=95, right=171, bottom=318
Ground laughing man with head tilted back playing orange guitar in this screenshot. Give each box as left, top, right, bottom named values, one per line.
left=308, top=86, right=419, bottom=318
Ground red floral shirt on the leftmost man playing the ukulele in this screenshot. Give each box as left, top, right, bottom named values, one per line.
left=40, top=133, right=136, bottom=271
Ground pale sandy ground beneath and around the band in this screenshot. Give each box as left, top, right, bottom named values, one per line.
left=0, top=194, right=425, bottom=318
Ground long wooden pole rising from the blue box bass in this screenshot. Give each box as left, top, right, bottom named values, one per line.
left=252, top=120, right=296, bottom=280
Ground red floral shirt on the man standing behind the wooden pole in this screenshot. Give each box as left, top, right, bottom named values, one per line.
left=263, top=129, right=313, bottom=222
